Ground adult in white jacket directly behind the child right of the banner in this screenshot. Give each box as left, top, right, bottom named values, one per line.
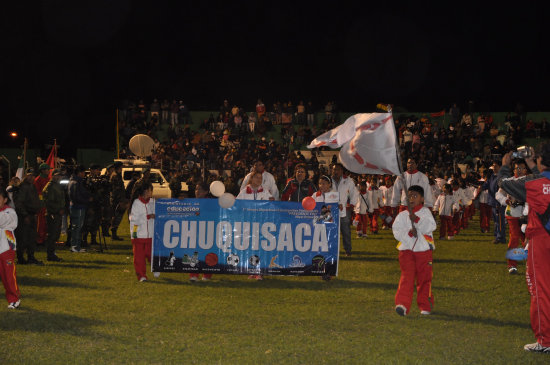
left=391, top=158, right=433, bottom=214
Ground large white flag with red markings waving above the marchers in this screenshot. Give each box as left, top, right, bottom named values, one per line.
left=307, top=113, right=401, bottom=175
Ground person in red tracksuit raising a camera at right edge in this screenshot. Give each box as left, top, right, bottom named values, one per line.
left=498, top=142, right=550, bottom=353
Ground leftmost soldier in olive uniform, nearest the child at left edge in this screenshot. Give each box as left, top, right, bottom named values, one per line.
left=15, top=169, right=44, bottom=265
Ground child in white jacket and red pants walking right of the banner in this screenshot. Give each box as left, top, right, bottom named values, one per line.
left=392, top=185, right=437, bottom=316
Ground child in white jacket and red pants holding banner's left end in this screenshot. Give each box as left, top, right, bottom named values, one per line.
left=128, top=182, right=155, bottom=282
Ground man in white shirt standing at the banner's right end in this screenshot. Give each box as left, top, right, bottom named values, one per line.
left=332, top=162, right=359, bottom=256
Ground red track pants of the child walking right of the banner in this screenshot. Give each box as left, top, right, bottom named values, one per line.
left=395, top=250, right=434, bottom=313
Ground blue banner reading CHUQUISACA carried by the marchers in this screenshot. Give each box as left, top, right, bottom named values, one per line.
left=152, top=199, right=339, bottom=276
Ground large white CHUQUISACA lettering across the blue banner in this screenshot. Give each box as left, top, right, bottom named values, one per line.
left=162, top=220, right=329, bottom=252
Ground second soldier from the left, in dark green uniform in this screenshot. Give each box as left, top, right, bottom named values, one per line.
left=42, top=169, right=65, bottom=262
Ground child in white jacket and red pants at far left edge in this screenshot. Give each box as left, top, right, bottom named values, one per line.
left=0, top=189, right=21, bottom=309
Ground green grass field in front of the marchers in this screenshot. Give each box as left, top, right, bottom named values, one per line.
left=0, top=212, right=550, bottom=364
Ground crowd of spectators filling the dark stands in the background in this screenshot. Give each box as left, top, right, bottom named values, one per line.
left=114, top=99, right=550, bottom=199
